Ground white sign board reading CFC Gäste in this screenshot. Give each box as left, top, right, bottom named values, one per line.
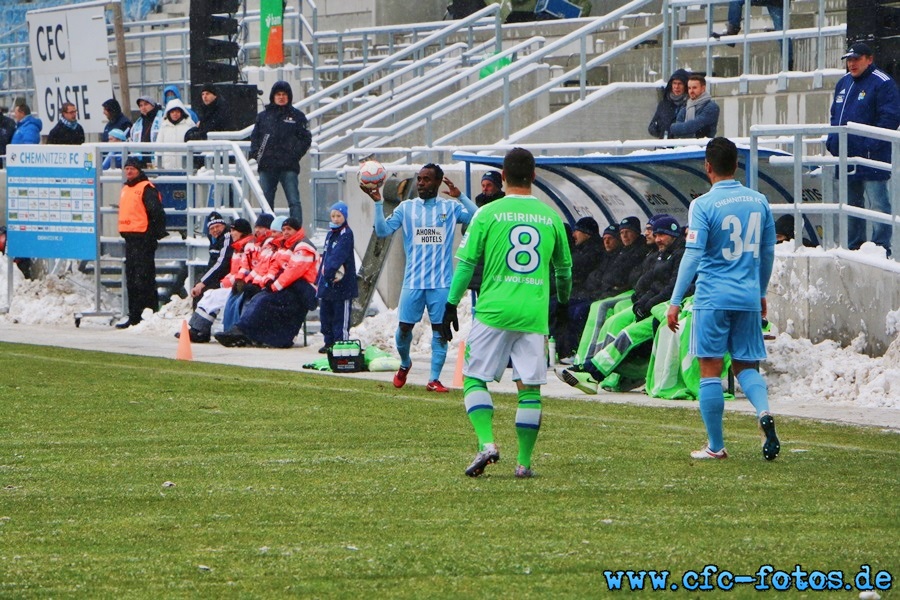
left=27, top=5, right=113, bottom=134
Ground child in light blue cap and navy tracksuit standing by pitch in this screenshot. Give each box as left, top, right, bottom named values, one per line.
left=316, top=202, right=359, bottom=354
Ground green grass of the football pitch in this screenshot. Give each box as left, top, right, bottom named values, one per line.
left=0, top=344, right=900, bottom=598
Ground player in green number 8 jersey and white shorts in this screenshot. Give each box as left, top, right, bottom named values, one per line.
left=442, top=148, right=572, bottom=478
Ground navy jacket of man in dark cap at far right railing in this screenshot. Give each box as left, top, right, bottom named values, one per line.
left=825, top=63, right=900, bottom=181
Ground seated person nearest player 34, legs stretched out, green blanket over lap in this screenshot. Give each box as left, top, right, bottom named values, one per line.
left=556, top=215, right=684, bottom=394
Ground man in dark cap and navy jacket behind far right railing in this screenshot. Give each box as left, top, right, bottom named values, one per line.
left=826, top=42, right=900, bottom=256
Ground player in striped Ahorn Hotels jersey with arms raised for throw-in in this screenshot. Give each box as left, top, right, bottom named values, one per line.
left=360, top=163, right=478, bottom=392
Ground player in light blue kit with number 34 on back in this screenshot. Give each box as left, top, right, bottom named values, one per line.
left=666, top=137, right=781, bottom=460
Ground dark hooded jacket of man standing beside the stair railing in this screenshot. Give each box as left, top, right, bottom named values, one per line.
left=250, top=81, right=312, bottom=173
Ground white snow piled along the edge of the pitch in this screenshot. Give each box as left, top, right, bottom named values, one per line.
left=0, top=250, right=900, bottom=409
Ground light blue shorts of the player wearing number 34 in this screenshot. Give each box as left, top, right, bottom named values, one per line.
left=691, top=308, right=766, bottom=362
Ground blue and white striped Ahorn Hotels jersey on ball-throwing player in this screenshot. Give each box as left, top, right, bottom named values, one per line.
left=375, top=194, right=478, bottom=290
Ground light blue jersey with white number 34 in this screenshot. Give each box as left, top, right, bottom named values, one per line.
left=686, top=179, right=775, bottom=311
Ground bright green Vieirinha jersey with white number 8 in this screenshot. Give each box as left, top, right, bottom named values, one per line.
left=456, top=196, right=572, bottom=335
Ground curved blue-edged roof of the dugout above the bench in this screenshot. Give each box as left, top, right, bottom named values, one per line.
left=453, top=146, right=809, bottom=228
